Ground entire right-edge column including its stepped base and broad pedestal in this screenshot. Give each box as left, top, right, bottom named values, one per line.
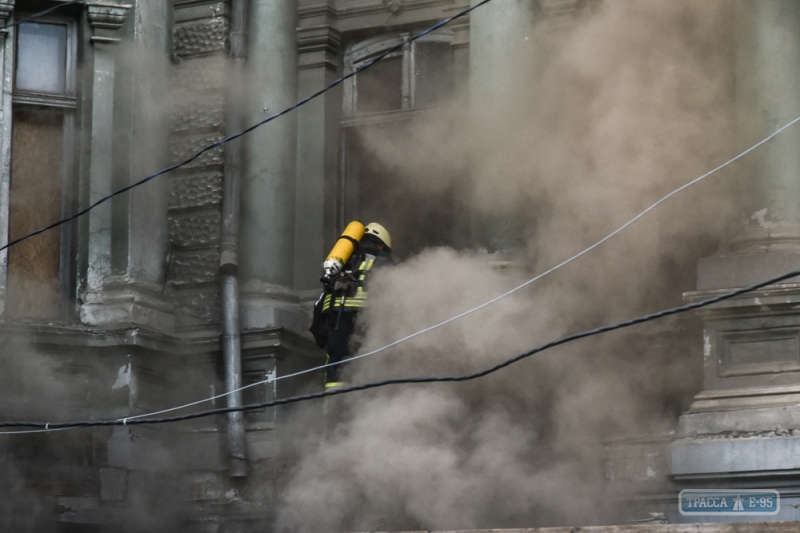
left=671, top=0, right=800, bottom=520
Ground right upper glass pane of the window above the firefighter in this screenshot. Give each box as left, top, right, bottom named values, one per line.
left=414, top=42, right=453, bottom=107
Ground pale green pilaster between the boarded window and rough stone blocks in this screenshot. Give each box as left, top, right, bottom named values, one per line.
left=80, top=3, right=175, bottom=330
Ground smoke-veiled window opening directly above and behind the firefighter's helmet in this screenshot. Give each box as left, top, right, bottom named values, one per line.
left=338, top=33, right=463, bottom=258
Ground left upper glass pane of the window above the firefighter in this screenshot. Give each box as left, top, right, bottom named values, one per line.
left=356, top=57, right=403, bottom=113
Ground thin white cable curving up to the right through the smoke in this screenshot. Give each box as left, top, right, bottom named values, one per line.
left=0, top=117, right=800, bottom=435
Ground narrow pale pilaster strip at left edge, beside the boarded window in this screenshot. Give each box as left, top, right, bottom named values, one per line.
left=0, top=0, right=14, bottom=315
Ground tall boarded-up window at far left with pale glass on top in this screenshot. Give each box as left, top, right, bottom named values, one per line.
left=6, top=19, right=75, bottom=319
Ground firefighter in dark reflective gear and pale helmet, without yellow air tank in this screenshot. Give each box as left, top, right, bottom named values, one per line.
left=312, top=222, right=392, bottom=390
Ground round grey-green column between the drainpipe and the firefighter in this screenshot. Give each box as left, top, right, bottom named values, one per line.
left=239, top=0, right=306, bottom=330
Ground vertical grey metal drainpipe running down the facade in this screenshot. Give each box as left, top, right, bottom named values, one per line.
left=219, top=0, right=247, bottom=477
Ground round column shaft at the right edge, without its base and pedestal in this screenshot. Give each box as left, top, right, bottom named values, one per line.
left=736, top=0, right=800, bottom=233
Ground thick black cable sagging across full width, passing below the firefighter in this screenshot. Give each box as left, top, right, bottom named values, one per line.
left=0, top=264, right=800, bottom=430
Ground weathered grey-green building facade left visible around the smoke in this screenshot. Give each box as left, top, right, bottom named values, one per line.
left=0, top=0, right=800, bottom=532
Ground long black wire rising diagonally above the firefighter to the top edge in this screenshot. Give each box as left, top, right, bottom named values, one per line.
left=0, top=0, right=492, bottom=252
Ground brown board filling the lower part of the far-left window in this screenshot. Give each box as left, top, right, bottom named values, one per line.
left=6, top=109, right=64, bottom=318
